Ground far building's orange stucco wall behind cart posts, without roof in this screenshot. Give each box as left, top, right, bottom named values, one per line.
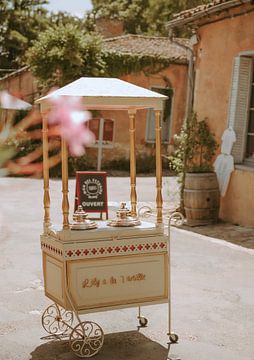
left=88, top=64, right=187, bottom=161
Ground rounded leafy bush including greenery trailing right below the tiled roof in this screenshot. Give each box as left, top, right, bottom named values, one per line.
left=26, top=23, right=173, bottom=91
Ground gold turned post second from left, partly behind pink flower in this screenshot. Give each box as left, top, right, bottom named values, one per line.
left=61, top=138, right=69, bottom=229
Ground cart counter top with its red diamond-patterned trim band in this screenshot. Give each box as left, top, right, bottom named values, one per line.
left=41, top=221, right=168, bottom=260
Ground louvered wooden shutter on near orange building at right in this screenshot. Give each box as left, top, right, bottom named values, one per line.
left=228, top=56, right=253, bottom=163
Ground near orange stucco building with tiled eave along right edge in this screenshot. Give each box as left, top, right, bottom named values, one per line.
left=169, top=0, right=254, bottom=226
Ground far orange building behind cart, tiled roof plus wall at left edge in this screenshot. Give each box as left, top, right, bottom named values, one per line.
left=0, top=33, right=188, bottom=169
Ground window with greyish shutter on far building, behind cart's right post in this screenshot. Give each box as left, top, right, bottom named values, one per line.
left=146, top=87, right=173, bottom=143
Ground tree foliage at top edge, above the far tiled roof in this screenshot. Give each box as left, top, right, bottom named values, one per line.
left=92, top=0, right=210, bottom=36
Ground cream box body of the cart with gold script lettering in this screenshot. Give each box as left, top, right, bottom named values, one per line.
left=41, top=219, right=168, bottom=313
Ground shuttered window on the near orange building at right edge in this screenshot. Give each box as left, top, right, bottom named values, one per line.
left=228, top=55, right=254, bottom=166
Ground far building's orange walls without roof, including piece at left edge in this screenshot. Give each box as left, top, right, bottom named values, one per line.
left=0, top=64, right=188, bottom=168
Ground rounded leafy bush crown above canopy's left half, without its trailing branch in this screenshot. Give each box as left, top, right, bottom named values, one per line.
left=26, top=24, right=105, bottom=89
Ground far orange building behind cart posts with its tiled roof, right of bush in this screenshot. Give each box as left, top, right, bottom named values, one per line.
left=91, top=35, right=188, bottom=165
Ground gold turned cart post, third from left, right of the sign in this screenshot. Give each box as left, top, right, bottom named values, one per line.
left=129, top=112, right=137, bottom=216
